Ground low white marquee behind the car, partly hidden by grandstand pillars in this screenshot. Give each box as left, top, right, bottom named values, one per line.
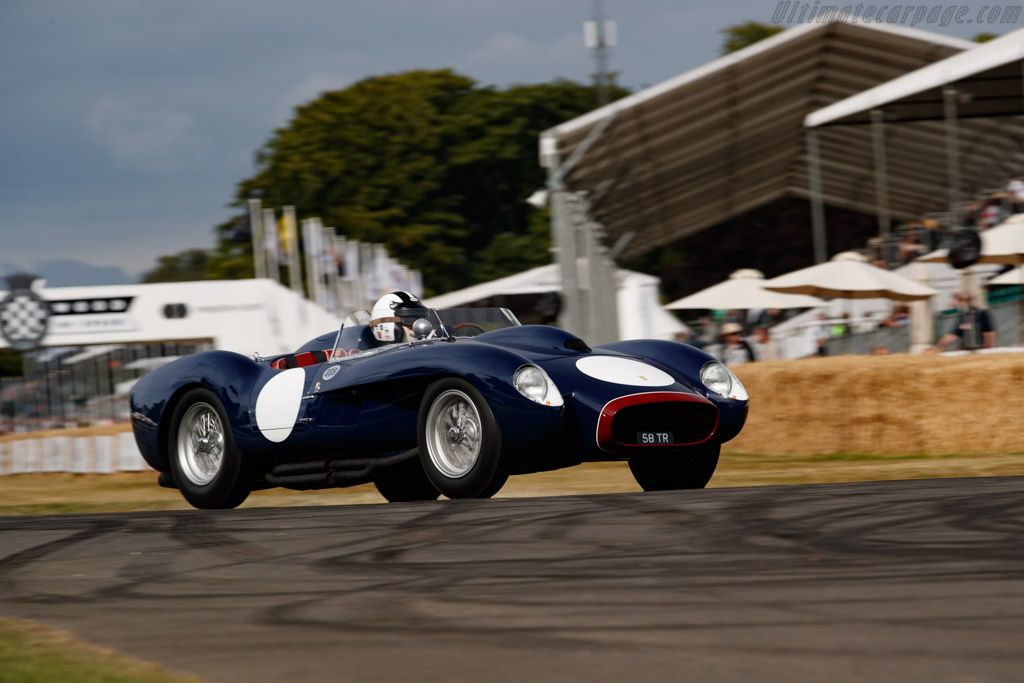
left=424, top=263, right=687, bottom=339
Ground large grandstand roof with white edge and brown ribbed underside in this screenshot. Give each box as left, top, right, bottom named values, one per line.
left=541, top=23, right=1024, bottom=256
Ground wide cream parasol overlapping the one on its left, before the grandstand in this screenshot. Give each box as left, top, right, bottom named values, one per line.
left=764, top=252, right=938, bottom=301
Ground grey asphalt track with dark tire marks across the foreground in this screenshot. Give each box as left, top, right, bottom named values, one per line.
left=0, top=477, right=1024, bottom=682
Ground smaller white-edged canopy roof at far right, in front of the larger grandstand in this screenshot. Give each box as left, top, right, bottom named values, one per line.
left=804, top=29, right=1024, bottom=128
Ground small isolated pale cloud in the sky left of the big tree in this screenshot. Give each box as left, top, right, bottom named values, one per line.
left=86, top=100, right=208, bottom=172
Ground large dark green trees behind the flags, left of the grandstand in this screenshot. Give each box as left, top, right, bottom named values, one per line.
left=156, top=70, right=627, bottom=294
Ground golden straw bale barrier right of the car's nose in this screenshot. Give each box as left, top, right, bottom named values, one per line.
left=724, top=353, right=1024, bottom=455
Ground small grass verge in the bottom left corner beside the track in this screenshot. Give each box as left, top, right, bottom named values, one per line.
left=0, top=618, right=203, bottom=683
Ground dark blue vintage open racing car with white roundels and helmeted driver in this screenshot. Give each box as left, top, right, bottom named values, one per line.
left=131, top=293, right=748, bottom=508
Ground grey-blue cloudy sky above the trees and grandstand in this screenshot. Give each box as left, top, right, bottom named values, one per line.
left=0, top=0, right=1024, bottom=285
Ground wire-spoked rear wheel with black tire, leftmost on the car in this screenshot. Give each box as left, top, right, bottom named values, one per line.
left=167, top=388, right=252, bottom=510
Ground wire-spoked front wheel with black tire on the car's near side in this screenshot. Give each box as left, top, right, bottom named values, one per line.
left=418, top=378, right=508, bottom=498
